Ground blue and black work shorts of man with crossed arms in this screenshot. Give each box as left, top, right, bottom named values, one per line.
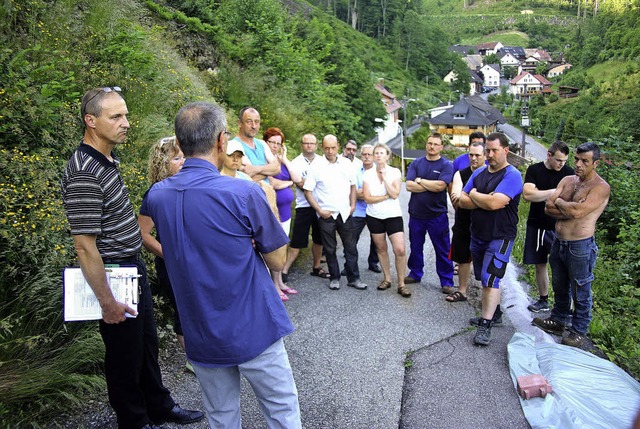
left=471, top=234, right=513, bottom=289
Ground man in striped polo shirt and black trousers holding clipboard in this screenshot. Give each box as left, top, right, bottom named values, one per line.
left=62, top=87, right=204, bottom=429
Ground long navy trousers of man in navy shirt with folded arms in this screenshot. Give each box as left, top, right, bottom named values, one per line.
left=407, top=213, right=453, bottom=286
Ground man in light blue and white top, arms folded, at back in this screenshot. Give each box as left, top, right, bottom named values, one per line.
left=233, top=106, right=280, bottom=182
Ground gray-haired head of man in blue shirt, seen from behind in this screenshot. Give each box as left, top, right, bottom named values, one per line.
left=175, top=102, right=227, bottom=157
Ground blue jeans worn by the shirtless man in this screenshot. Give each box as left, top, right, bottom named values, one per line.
left=549, top=237, right=598, bottom=334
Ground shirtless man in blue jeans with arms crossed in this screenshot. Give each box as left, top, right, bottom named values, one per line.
left=532, top=143, right=611, bottom=347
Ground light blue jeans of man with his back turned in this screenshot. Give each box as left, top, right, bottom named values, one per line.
left=193, top=338, right=302, bottom=429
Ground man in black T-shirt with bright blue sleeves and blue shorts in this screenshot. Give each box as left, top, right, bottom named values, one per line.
left=459, top=133, right=522, bottom=346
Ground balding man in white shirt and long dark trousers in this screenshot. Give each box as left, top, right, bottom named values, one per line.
left=303, top=134, right=367, bottom=290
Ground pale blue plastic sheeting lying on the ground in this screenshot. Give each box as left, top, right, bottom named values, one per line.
left=507, top=332, right=640, bottom=429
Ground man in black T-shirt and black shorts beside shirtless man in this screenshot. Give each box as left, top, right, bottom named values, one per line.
left=522, top=141, right=573, bottom=313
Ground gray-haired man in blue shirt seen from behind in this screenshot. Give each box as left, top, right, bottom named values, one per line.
left=144, top=102, right=301, bottom=428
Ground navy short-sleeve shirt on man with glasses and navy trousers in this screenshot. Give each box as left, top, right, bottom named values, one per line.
left=407, top=156, right=453, bottom=219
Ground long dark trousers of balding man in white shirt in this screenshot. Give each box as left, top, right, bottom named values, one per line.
left=318, top=215, right=360, bottom=283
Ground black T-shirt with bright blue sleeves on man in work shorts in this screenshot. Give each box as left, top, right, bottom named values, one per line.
left=464, top=165, right=522, bottom=241
